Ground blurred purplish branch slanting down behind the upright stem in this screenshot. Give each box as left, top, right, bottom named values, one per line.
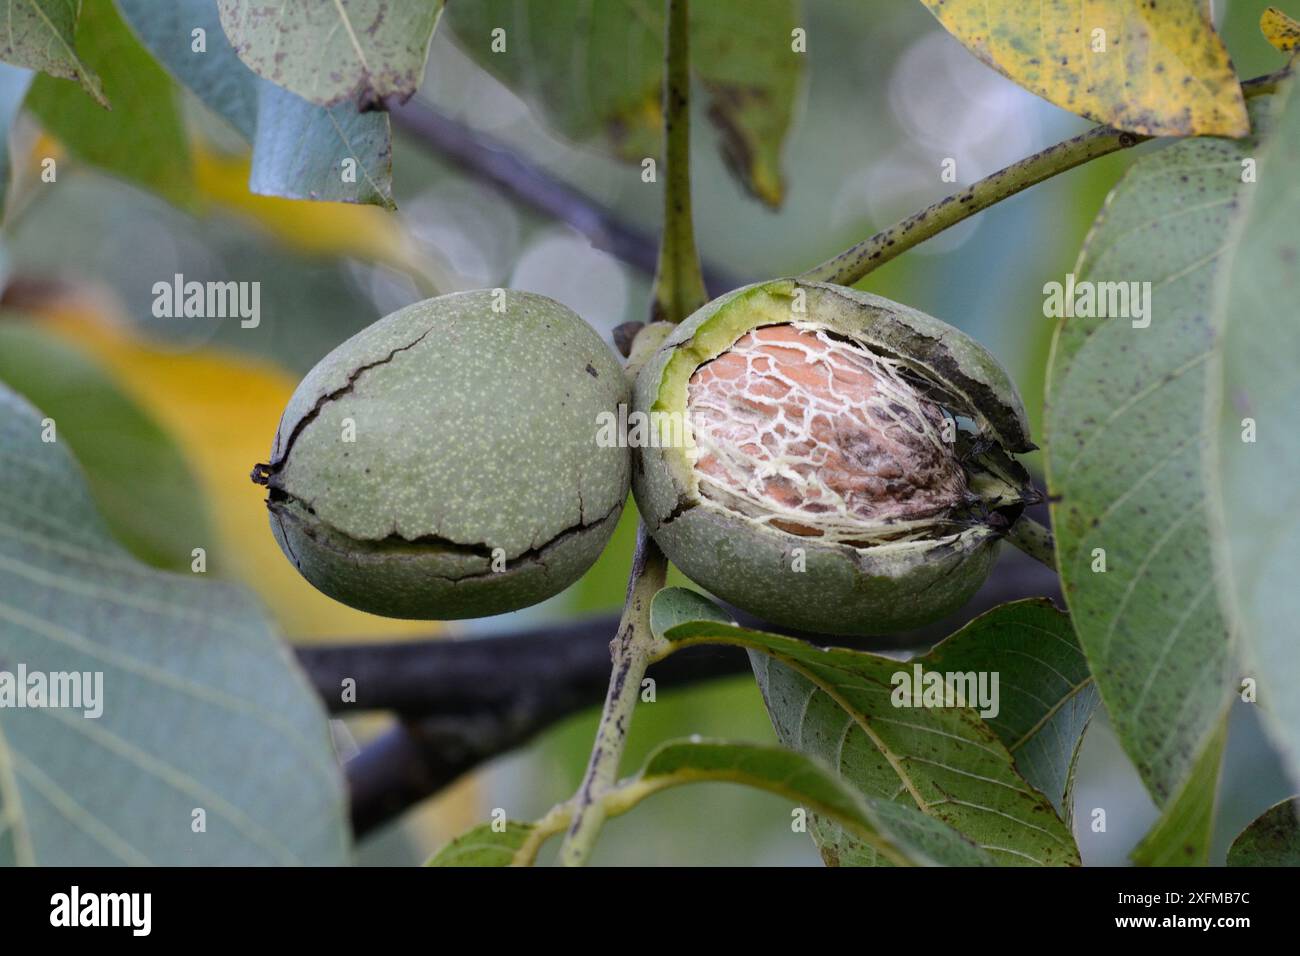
left=387, top=99, right=745, bottom=295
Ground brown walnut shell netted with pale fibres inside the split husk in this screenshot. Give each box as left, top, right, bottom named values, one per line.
left=686, top=324, right=966, bottom=540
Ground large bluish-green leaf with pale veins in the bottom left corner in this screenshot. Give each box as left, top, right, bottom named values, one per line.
left=0, top=388, right=347, bottom=866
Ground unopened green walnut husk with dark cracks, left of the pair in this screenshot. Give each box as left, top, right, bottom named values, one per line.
left=254, top=290, right=629, bottom=619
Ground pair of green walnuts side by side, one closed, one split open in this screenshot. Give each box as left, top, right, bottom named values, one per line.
left=254, top=280, right=1034, bottom=633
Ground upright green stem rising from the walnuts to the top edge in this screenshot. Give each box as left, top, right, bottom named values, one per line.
left=650, top=0, right=709, bottom=323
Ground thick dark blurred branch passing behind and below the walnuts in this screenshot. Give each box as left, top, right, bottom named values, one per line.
left=309, top=549, right=1061, bottom=838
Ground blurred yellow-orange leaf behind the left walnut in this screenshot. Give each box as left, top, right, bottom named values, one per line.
left=25, top=287, right=439, bottom=640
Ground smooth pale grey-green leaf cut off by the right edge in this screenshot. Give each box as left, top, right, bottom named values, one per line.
left=1206, top=81, right=1300, bottom=780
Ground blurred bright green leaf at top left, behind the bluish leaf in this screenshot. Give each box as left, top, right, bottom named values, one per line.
left=27, top=0, right=192, bottom=206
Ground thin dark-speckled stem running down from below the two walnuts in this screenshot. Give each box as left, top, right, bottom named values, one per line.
left=560, top=524, right=672, bottom=866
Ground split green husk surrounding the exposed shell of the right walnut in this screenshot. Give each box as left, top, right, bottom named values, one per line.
left=633, top=280, right=1037, bottom=635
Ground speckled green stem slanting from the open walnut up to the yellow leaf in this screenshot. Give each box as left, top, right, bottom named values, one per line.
left=800, top=69, right=1291, bottom=285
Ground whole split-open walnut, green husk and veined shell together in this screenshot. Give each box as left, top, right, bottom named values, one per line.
left=632, top=278, right=1035, bottom=633
